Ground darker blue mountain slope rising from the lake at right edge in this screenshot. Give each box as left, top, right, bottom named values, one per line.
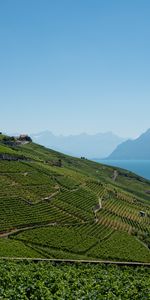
left=108, top=129, right=150, bottom=160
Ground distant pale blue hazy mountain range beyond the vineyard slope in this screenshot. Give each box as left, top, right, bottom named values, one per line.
left=30, top=131, right=125, bottom=158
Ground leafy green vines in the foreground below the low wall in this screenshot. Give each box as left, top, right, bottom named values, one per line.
left=0, top=261, right=150, bottom=300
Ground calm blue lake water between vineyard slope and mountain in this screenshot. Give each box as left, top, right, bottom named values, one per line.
left=95, top=159, right=150, bottom=179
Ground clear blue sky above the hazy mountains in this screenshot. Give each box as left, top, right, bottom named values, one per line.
left=0, top=0, right=150, bottom=137
